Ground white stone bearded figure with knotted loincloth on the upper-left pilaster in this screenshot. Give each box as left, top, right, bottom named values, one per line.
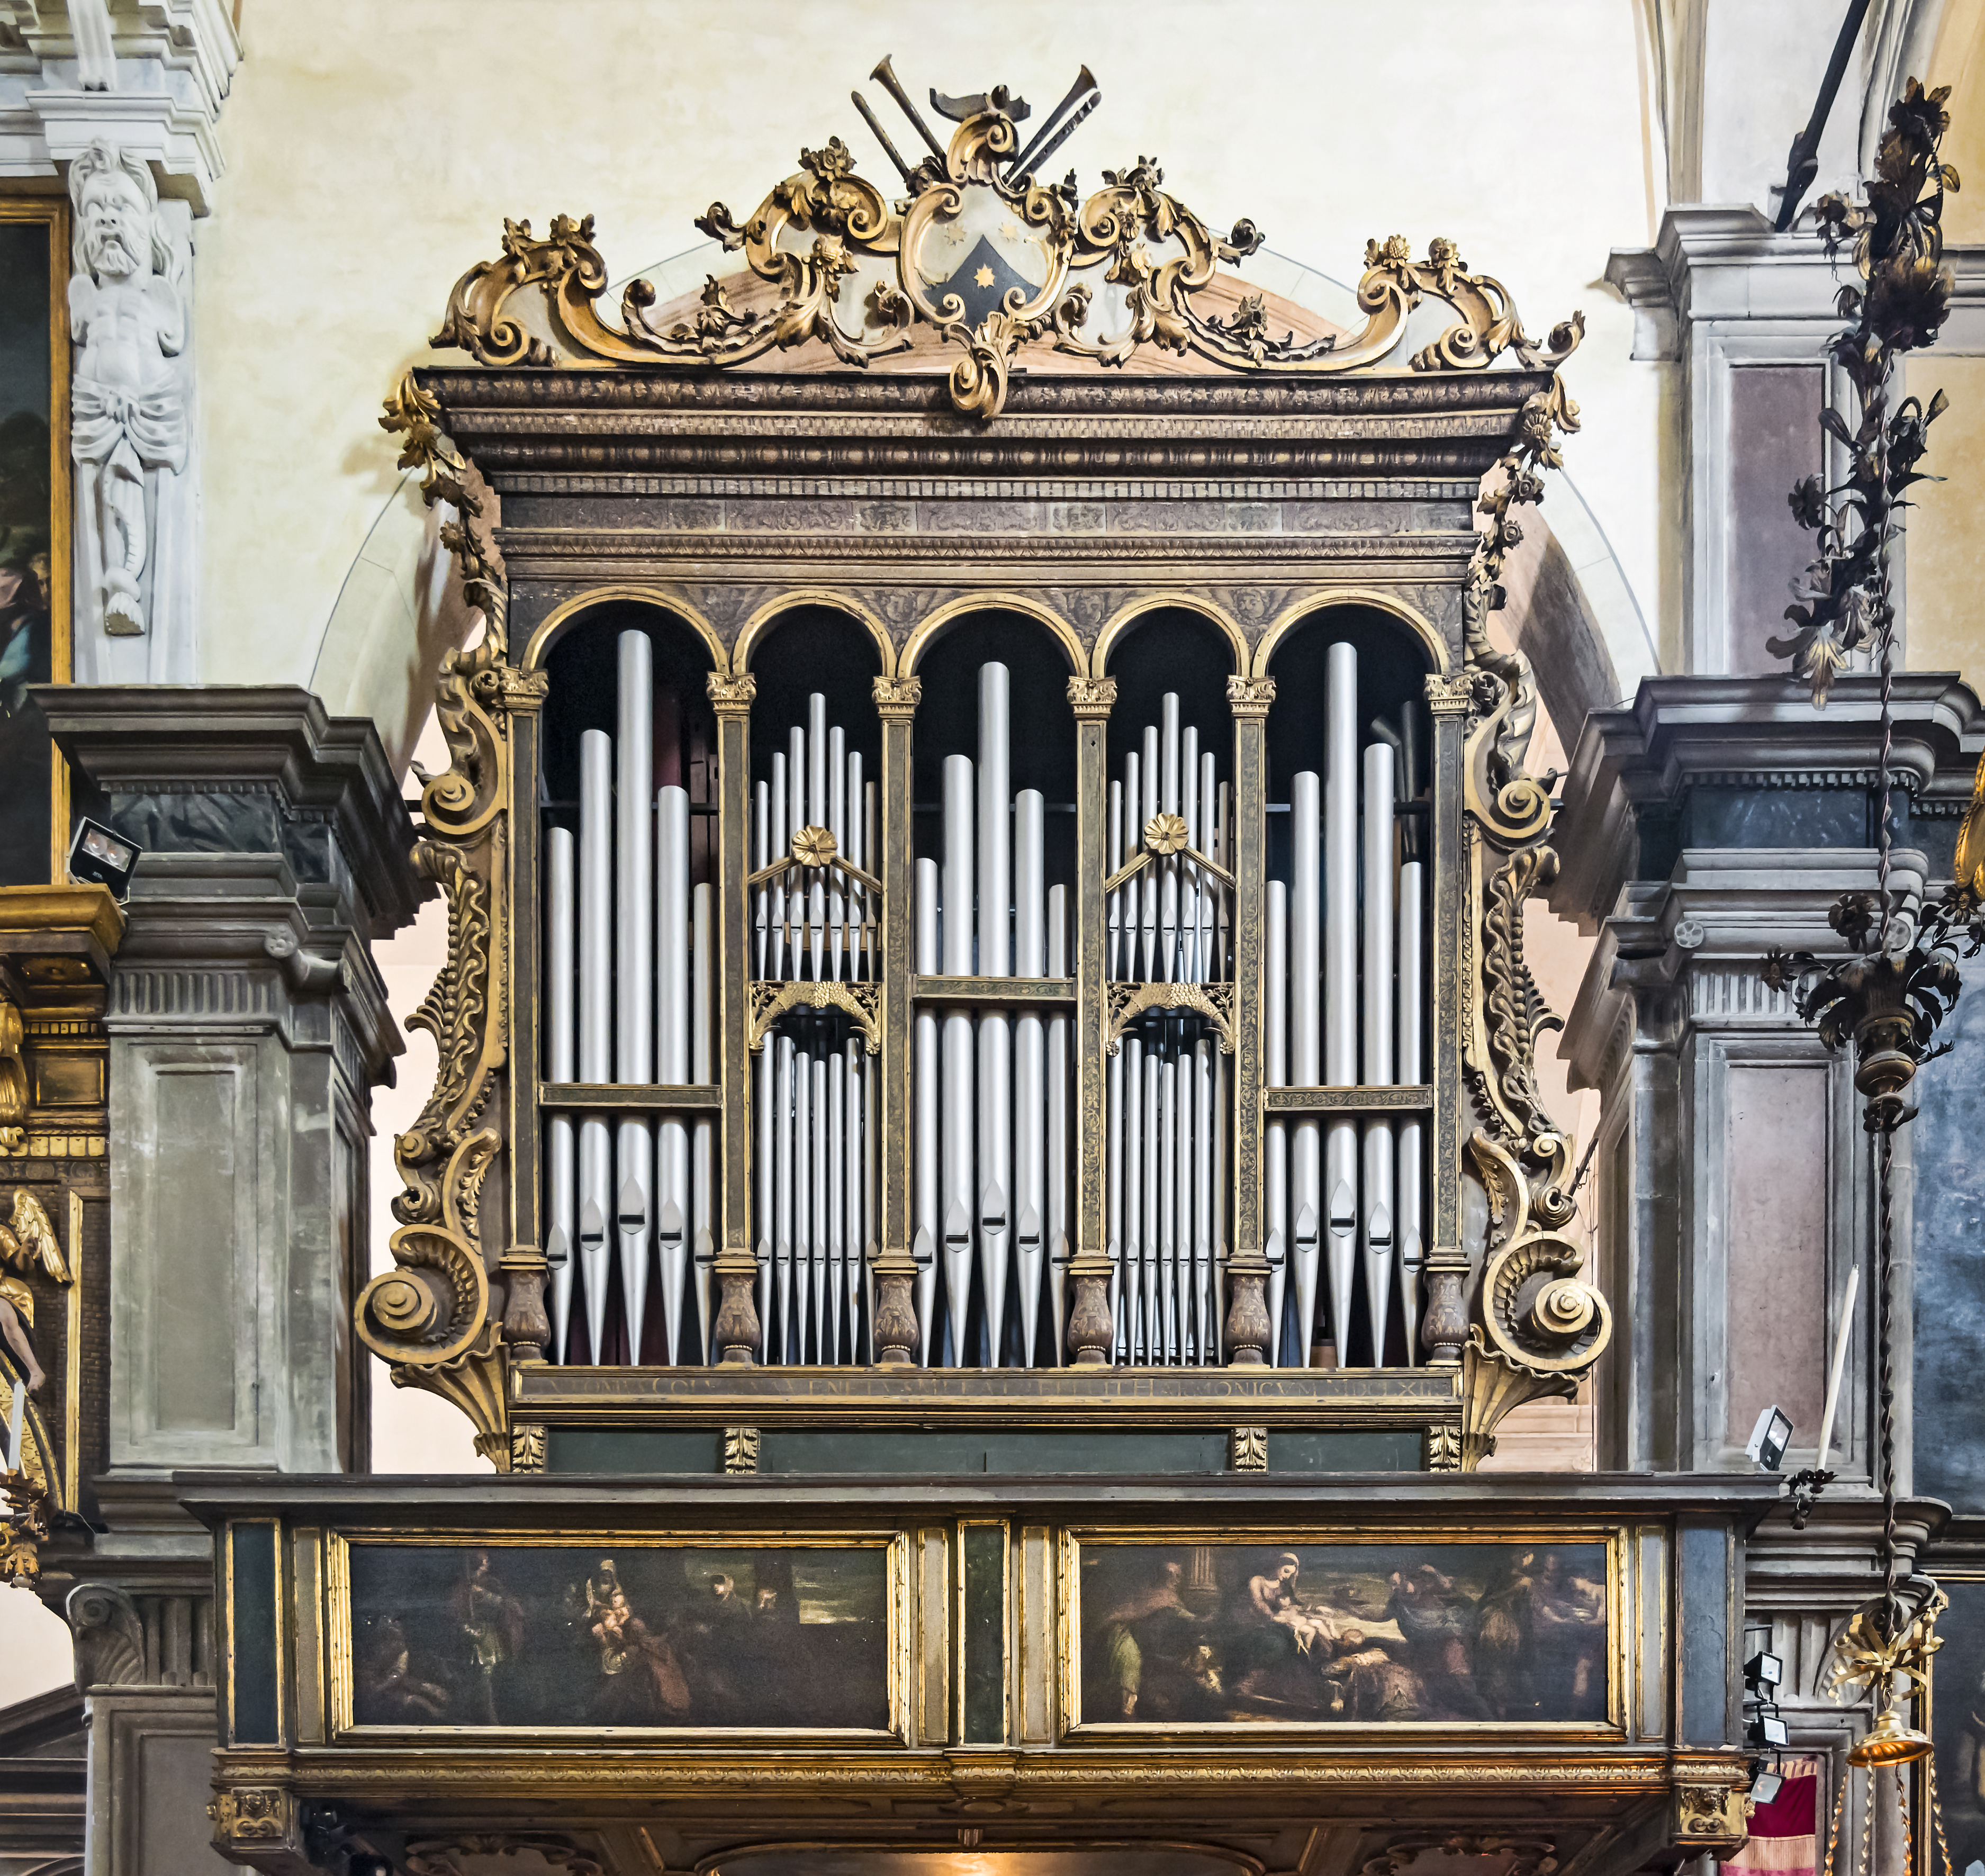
left=69, top=139, right=188, bottom=647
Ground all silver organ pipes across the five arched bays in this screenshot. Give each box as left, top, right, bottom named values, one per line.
left=546, top=632, right=1427, bottom=1368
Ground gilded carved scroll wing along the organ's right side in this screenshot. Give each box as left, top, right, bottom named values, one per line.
left=1455, top=379, right=1612, bottom=1469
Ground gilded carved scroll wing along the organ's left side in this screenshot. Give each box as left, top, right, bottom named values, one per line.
left=355, top=375, right=546, bottom=1467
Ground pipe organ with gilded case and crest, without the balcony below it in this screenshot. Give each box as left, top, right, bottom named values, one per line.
left=357, top=93, right=1610, bottom=1469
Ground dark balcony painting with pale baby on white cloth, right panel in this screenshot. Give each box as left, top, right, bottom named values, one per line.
left=1076, top=1540, right=1612, bottom=1727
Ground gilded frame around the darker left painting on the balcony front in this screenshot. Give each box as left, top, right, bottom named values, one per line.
left=321, top=1529, right=913, bottom=1749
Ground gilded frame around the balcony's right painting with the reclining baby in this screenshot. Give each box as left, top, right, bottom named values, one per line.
left=1056, top=1522, right=1634, bottom=1743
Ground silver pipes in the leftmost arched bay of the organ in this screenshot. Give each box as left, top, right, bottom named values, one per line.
left=544, top=632, right=717, bottom=1366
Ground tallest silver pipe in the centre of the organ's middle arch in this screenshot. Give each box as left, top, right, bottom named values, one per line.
left=977, top=663, right=1013, bottom=1368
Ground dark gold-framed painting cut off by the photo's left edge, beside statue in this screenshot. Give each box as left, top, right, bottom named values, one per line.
left=0, top=196, right=68, bottom=886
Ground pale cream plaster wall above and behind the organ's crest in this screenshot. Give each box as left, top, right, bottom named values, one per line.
left=196, top=0, right=1662, bottom=735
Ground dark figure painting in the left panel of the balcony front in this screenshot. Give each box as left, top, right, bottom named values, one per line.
left=349, top=1540, right=894, bottom=1733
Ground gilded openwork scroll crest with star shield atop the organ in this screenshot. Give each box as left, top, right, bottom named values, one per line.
left=435, top=68, right=1584, bottom=421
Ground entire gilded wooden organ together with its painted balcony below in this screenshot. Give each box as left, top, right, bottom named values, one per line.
left=187, top=80, right=1763, bottom=1876
